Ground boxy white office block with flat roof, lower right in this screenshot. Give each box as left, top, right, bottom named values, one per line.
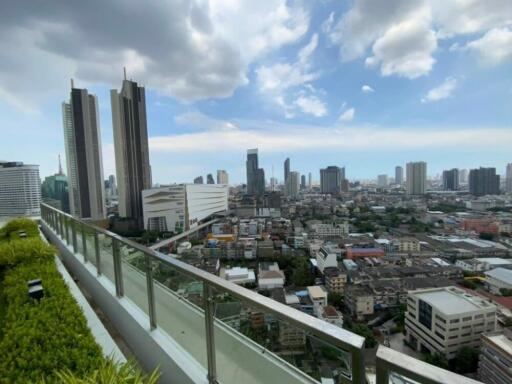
left=405, top=287, right=496, bottom=360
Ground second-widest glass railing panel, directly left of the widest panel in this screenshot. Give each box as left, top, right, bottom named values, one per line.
left=153, top=260, right=207, bottom=369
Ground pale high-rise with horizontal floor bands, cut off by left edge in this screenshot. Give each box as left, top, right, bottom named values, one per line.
left=0, top=161, right=41, bottom=217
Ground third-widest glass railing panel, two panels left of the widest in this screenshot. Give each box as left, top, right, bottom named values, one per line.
left=119, top=243, right=148, bottom=314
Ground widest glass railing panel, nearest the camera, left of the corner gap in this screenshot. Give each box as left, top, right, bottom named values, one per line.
left=210, top=291, right=351, bottom=384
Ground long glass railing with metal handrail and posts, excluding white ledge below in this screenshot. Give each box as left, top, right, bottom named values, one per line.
left=41, top=204, right=484, bottom=384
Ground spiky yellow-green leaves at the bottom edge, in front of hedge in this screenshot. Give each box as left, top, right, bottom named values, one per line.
left=51, top=359, right=160, bottom=384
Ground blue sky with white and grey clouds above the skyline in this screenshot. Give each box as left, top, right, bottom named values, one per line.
left=0, top=0, right=512, bottom=184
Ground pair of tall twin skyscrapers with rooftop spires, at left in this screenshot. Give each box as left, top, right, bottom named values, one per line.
left=62, top=71, right=151, bottom=227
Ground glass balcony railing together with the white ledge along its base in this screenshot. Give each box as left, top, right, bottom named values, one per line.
left=41, top=204, right=484, bottom=384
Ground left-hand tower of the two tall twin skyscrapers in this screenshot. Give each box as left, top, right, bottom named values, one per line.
left=62, top=81, right=106, bottom=220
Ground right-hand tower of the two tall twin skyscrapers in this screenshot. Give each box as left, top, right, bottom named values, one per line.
left=110, top=72, right=151, bottom=227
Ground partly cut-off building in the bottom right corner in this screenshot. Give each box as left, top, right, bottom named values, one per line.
left=478, top=328, right=512, bottom=384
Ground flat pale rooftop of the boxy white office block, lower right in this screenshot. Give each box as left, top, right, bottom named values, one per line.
left=412, top=287, right=494, bottom=316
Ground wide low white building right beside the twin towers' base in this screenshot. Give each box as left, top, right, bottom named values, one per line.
left=142, top=184, right=228, bottom=232
